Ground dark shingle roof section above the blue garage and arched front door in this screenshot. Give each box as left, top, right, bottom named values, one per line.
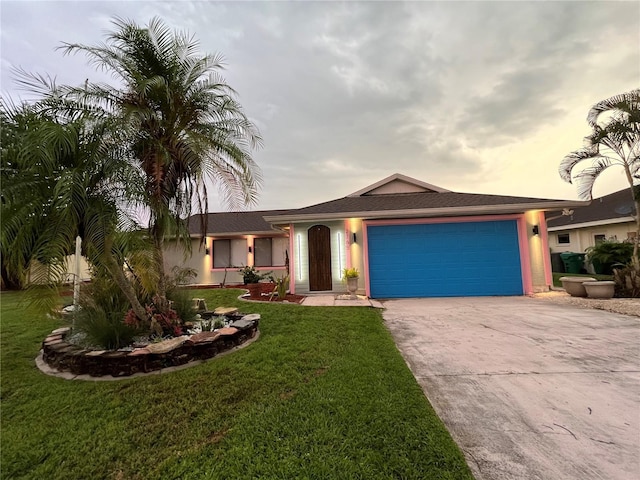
left=266, top=192, right=585, bottom=222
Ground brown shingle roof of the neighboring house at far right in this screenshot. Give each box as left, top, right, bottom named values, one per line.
left=547, top=188, right=636, bottom=228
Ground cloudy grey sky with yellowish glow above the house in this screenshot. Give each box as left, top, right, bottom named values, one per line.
left=0, top=0, right=640, bottom=211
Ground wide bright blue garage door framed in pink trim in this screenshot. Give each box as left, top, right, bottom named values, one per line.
left=367, top=220, right=523, bottom=298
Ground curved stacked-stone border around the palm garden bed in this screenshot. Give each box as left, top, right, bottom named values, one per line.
left=41, top=314, right=260, bottom=377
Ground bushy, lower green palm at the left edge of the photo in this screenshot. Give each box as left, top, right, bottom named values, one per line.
left=0, top=98, right=147, bottom=318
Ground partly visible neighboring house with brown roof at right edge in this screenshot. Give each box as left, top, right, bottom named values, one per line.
left=546, top=188, right=637, bottom=253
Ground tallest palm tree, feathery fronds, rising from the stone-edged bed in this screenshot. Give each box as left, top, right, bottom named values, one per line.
left=57, top=18, right=261, bottom=308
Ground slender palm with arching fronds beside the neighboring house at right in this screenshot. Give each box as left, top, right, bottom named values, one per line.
left=559, top=89, right=640, bottom=269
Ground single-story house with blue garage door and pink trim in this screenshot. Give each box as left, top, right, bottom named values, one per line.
left=167, top=174, right=587, bottom=298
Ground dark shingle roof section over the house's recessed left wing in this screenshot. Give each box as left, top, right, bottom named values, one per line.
left=189, top=210, right=288, bottom=235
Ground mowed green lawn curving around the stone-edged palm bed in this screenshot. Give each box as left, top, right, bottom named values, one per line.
left=0, top=290, right=472, bottom=479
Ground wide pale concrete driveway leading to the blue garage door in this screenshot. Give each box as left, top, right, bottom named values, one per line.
left=383, top=297, right=640, bottom=480
